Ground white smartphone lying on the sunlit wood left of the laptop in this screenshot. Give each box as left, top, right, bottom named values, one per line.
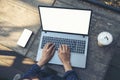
left=17, top=29, right=32, bottom=47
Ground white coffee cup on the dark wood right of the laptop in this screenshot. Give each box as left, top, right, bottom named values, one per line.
left=97, top=32, right=113, bottom=46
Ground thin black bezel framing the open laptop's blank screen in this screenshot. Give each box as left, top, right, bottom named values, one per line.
left=38, top=5, right=92, bottom=36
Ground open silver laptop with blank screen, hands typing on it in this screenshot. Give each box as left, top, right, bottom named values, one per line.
left=36, top=6, right=91, bottom=68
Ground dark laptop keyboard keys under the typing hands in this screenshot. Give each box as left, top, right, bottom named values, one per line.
left=41, top=36, right=86, bottom=54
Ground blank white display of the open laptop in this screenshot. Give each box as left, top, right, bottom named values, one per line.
left=39, top=7, right=91, bottom=35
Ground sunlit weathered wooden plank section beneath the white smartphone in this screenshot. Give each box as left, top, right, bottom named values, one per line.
left=0, top=0, right=54, bottom=55
